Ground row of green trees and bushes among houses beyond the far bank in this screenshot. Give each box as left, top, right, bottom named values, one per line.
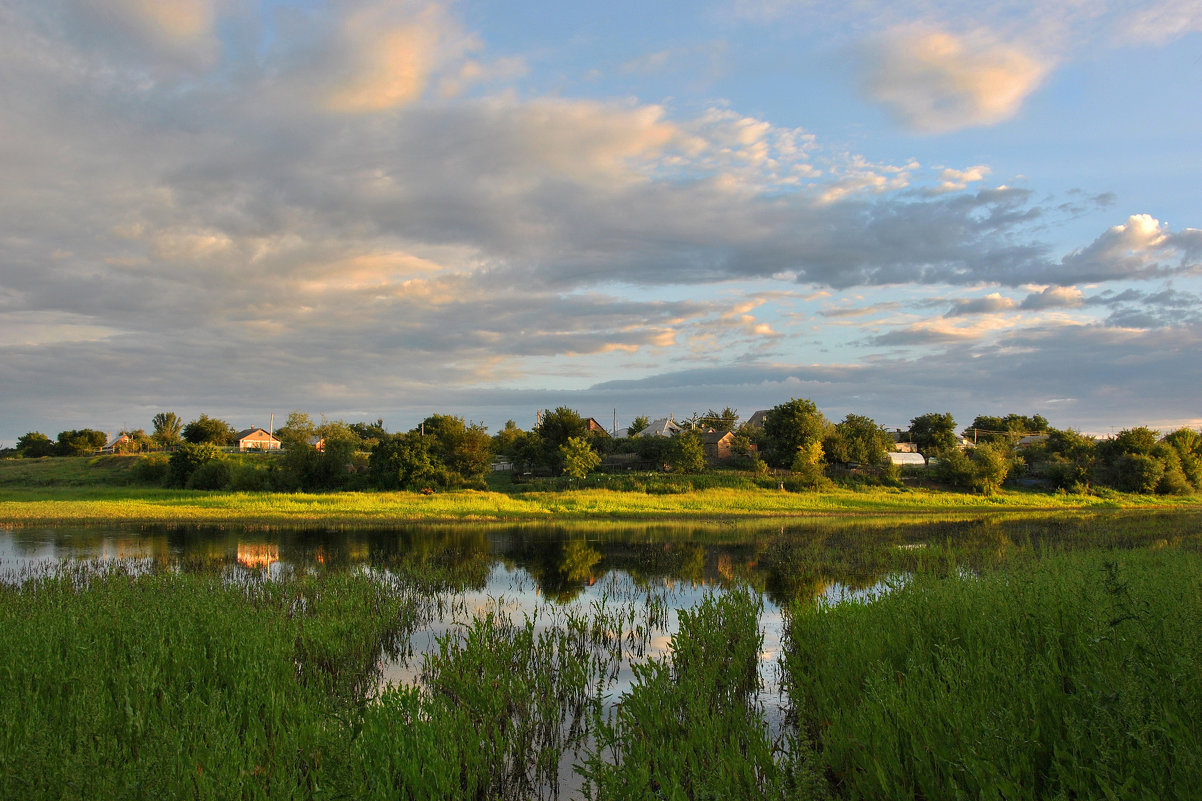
left=10, top=398, right=1202, bottom=494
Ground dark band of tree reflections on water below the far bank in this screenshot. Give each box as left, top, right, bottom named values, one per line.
left=7, top=511, right=1202, bottom=604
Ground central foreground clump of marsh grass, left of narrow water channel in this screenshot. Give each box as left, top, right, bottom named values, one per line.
left=581, top=591, right=820, bottom=799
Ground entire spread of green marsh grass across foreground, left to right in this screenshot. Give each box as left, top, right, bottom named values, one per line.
left=0, top=538, right=1202, bottom=800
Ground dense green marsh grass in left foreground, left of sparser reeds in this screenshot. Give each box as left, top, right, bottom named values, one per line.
left=0, top=565, right=423, bottom=799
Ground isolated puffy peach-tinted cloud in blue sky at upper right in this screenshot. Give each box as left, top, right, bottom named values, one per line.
left=861, top=28, right=1051, bottom=134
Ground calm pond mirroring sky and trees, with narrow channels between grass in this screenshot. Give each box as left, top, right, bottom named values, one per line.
left=0, top=512, right=1198, bottom=797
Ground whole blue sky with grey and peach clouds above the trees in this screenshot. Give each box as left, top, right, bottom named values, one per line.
left=0, top=0, right=1202, bottom=446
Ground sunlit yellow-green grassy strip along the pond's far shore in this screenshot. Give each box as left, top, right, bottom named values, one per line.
left=0, top=487, right=1202, bottom=527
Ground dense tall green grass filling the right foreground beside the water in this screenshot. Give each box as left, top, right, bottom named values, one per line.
left=787, top=551, right=1202, bottom=799
